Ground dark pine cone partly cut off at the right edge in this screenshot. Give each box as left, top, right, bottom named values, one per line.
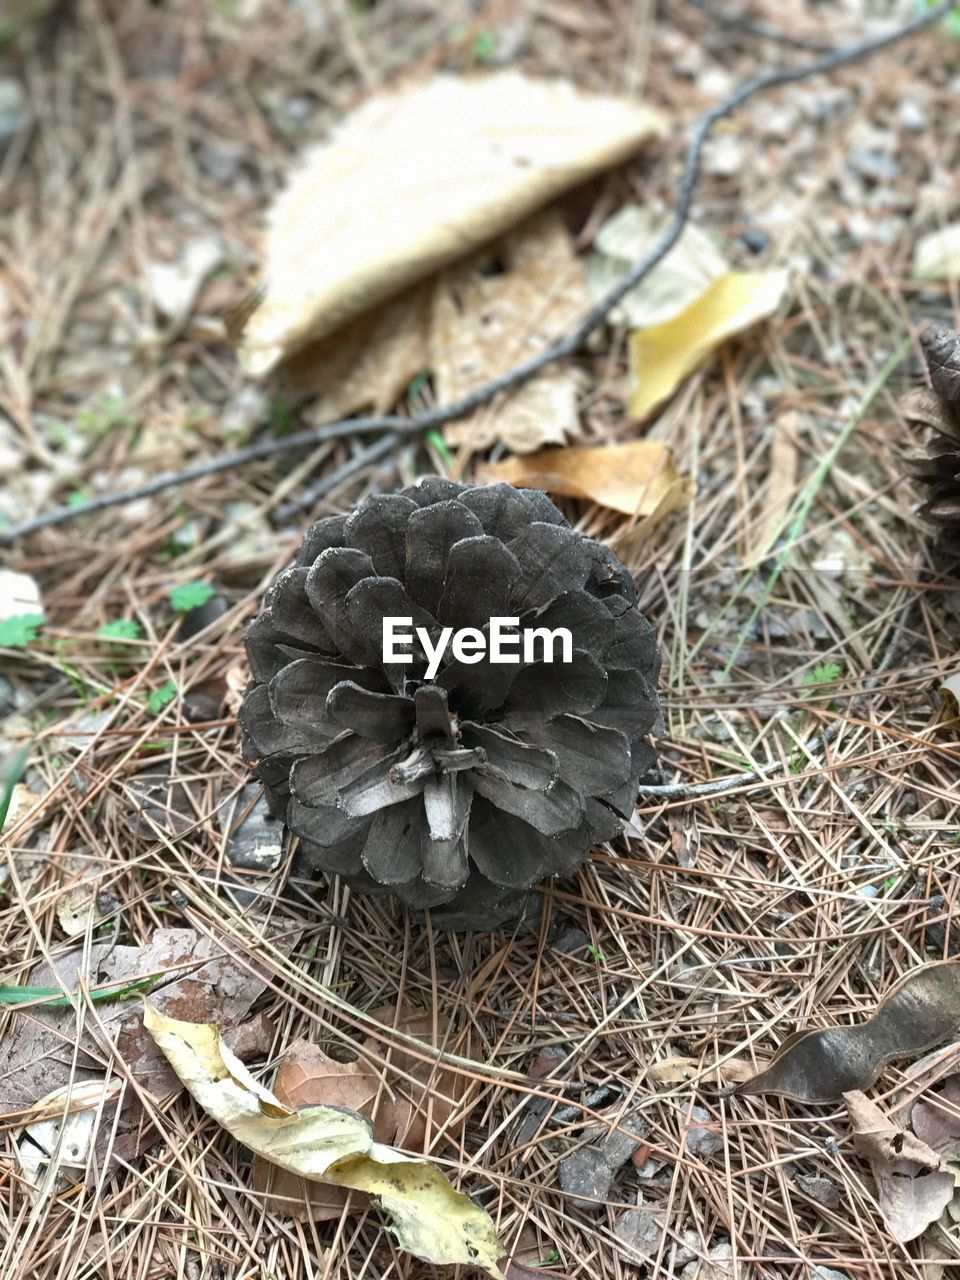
left=901, top=326, right=960, bottom=563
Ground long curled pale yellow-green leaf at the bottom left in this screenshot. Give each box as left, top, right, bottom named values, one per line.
left=143, top=1001, right=504, bottom=1280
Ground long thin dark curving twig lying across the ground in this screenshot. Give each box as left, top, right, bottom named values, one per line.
left=0, top=0, right=956, bottom=545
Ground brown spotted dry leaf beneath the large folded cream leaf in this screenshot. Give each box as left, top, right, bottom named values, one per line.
left=280, top=211, right=588, bottom=453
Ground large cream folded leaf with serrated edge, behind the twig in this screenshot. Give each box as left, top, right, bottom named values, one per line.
left=241, top=70, right=663, bottom=374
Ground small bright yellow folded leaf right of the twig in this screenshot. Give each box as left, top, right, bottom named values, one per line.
left=630, top=271, right=787, bottom=417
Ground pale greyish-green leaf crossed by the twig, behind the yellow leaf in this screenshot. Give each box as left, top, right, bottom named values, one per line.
left=586, top=205, right=728, bottom=329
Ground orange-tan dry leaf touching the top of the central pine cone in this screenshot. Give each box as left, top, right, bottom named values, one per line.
left=483, top=440, right=694, bottom=516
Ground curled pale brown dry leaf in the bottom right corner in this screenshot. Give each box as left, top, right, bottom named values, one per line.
left=844, top=1091, right=956, bottom=1242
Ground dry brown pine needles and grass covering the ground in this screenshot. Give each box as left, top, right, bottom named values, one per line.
left=0, top=0, right=960, bottom=1280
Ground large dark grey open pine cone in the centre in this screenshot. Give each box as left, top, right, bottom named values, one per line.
left=239, top=477, right=660, bottom=928
